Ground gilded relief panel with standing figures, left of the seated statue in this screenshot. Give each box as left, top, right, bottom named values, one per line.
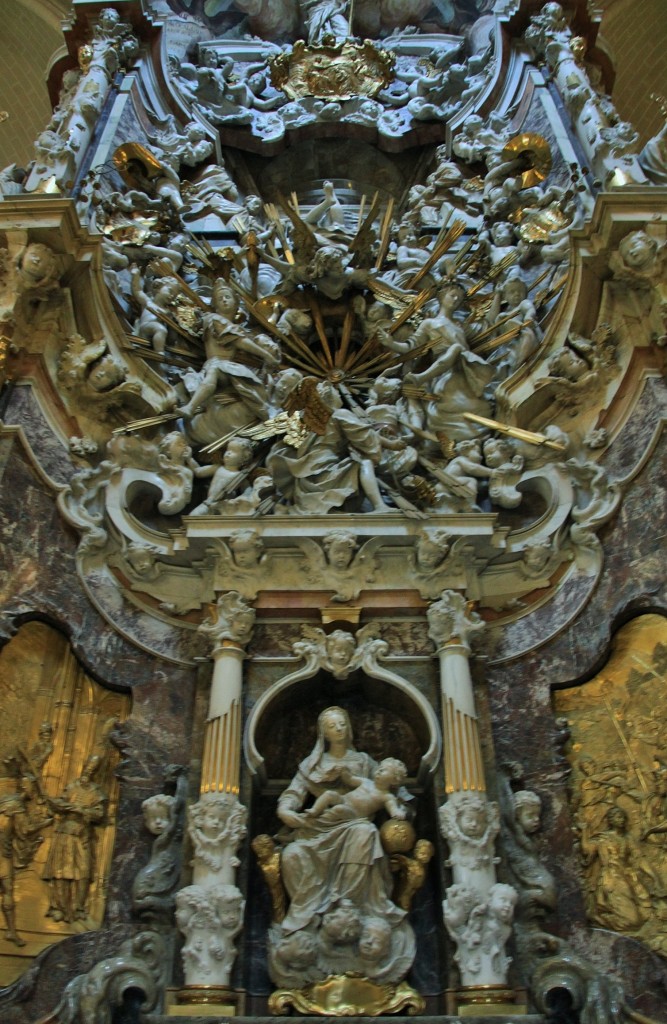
left=0, top=623, right=129, bottom=985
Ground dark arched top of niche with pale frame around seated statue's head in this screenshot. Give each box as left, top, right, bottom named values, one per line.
left=244, top=659, right=442, bottom=790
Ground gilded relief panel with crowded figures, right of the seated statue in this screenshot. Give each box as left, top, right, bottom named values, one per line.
left=554, top=615, right=667, bottom=955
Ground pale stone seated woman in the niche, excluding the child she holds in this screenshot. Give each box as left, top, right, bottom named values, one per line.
left=269, top=708, right=415, bottom=983
